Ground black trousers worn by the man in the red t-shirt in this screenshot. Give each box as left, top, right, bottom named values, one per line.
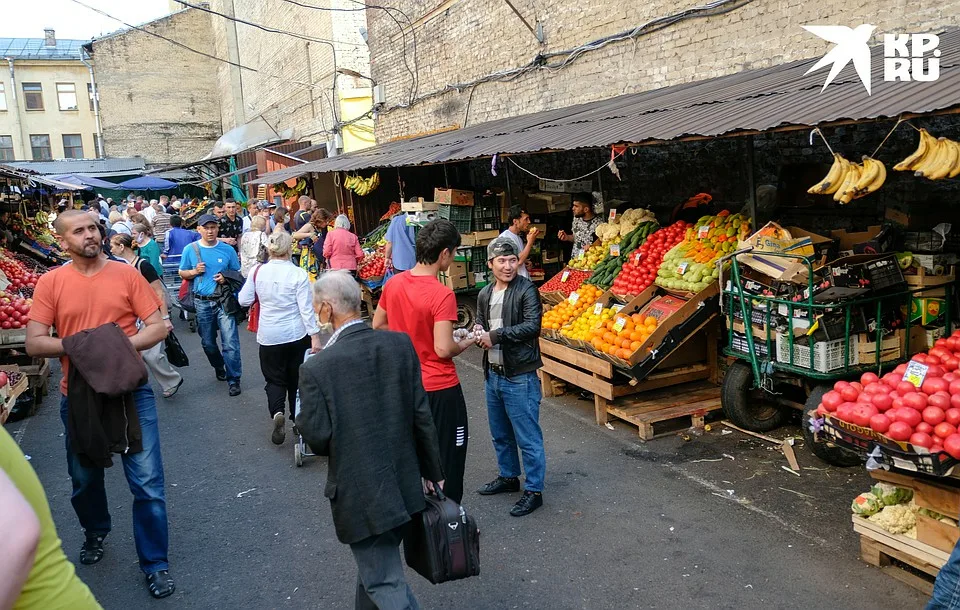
left=427, top=383, right=468, bottom=504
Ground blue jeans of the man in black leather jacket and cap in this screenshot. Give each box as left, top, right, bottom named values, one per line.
left=486, top=371, right=547, bottom=491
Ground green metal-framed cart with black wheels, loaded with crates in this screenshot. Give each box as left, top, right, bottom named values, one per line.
left=720, top=249, right=958, bottom=466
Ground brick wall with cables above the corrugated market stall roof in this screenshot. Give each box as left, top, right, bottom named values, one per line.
left=367, top=0, right=960, bottom=141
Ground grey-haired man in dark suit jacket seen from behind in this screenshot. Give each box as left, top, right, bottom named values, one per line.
left=297, top=271, right=443, bottom=610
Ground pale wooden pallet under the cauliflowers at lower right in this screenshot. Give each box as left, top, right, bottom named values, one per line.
left=853, top=516, right=950, bottom=595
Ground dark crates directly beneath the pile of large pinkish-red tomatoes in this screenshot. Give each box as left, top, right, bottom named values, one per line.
left=811, top=415, right=960, bottom=477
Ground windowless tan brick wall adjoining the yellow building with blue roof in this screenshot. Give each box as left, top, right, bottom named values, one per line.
left=93, top=9, right=221, bottom=163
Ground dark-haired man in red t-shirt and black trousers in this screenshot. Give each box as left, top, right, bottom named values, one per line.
left=373, top=220, right=473, bottom=503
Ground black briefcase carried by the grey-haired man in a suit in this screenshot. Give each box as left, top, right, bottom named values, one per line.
left=403, top=484, right=480, bottom=585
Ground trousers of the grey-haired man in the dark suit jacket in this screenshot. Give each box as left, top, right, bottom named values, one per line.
left=350, top=524, right=420, bottom=610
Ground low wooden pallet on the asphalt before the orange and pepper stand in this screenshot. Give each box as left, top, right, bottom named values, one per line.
left=607, top=383, right=720, bottom=441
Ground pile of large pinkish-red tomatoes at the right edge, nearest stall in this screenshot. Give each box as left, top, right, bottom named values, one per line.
left=817, top=330, right=960, bottom=459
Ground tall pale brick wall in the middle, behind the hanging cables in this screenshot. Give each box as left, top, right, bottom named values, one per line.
left=210, top=0, right=370, bottom=141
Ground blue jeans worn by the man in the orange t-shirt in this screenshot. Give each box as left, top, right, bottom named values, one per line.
left=60, top=384, right=168, bottom=574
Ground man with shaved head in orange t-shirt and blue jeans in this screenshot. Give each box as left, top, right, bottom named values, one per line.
left=27, top=210, right=175, bottom=598
